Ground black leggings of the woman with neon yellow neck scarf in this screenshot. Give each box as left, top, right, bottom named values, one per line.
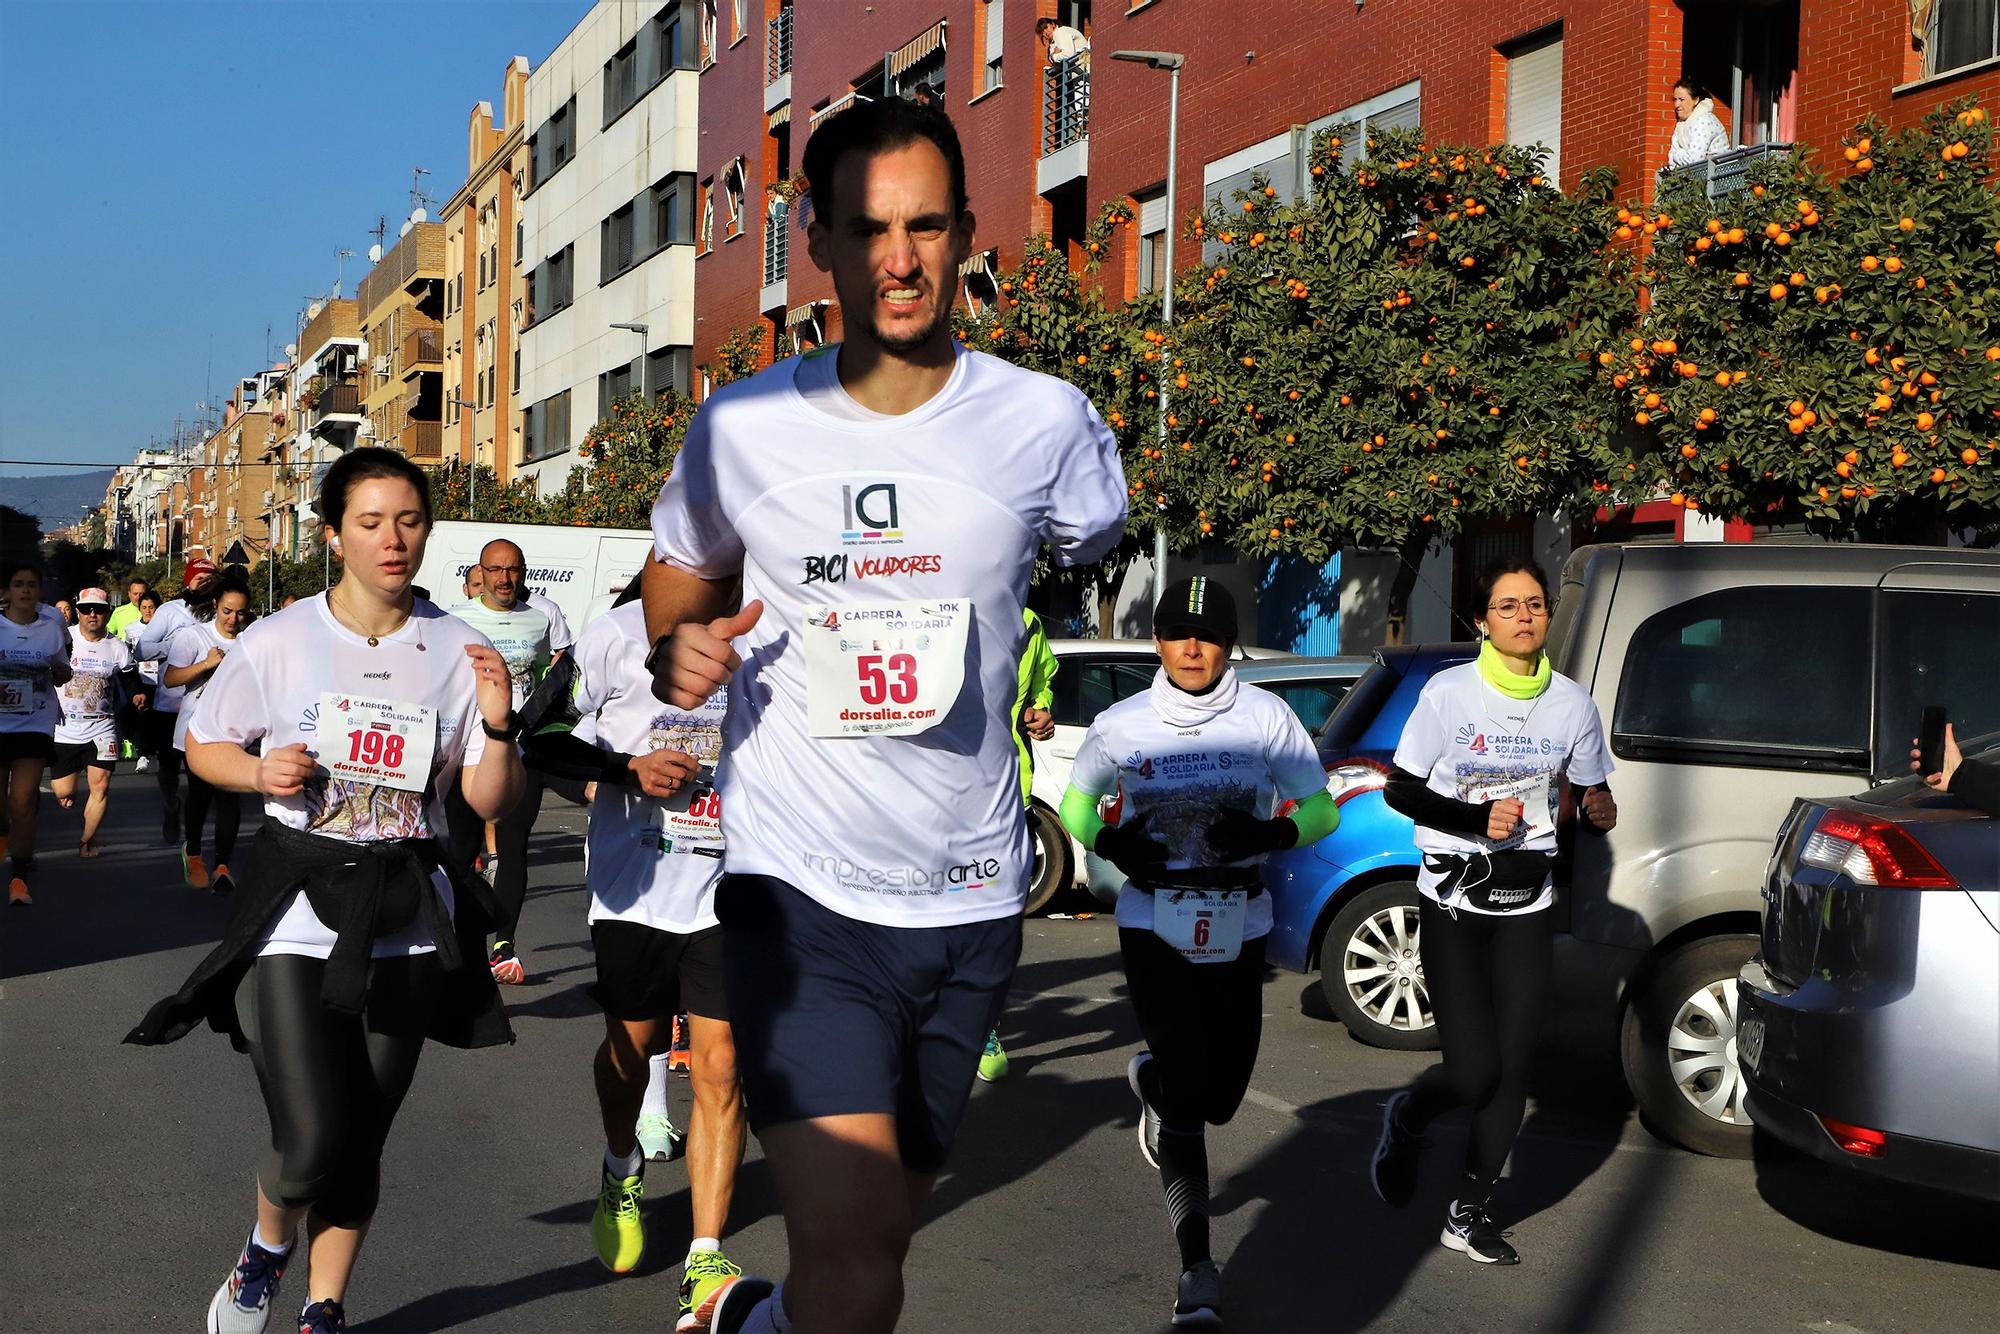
left=1402, top=898, right=1556, bottom=1200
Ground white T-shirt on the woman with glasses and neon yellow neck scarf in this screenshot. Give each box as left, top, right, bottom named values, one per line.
left=1396, top=662, right=1612, bottom=916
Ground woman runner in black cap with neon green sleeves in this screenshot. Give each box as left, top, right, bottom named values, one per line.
left=1062, top=576, right=1340, bottom=1326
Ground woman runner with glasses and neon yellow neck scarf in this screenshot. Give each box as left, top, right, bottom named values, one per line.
left=1370, top=560, right=1618, bottom=1264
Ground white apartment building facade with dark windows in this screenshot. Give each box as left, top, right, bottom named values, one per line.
left=516, top=0, right=698, bottom=492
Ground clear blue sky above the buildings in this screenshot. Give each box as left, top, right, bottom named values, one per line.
left=0, top=0, right=590, bottom=476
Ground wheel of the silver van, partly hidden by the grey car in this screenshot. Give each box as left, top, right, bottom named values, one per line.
left=1620, top=936, right=1758, bottom=1158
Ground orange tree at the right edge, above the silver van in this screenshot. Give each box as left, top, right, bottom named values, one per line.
left=1598, top=102, right=2000, bottom=542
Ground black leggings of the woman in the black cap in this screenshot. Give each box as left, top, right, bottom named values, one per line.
left=1118, top=926, right=1264, bottom=1130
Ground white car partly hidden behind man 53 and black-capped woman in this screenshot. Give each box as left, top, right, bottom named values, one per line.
left=1026, top=640, right=1294, bottom=912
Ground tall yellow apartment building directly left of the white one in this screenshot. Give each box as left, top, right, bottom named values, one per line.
left=438, top=56, right=528, bottom=484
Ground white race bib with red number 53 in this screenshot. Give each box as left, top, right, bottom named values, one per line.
left=802, top=598, right=972, bottom=736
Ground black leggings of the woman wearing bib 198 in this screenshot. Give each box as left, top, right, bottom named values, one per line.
left=236, top=954, right=440, bottom=1228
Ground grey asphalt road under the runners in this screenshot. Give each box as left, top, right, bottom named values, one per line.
left=0, top=774, right=2000, bottom=1334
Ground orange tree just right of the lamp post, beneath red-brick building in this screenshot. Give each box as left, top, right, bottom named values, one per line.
left=1144, top=126, right=1632, bottom=618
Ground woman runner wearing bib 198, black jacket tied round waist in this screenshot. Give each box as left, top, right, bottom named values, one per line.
left=126, top=448, right=522, bottom=1334
